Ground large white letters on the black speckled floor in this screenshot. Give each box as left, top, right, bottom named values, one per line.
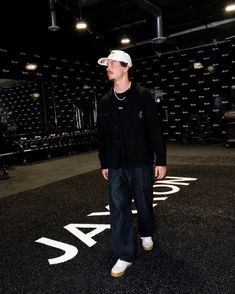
left=35, top=176, right=197, bottom=265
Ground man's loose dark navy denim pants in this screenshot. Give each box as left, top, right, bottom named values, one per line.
left=109, top=166, right=154, bottom=261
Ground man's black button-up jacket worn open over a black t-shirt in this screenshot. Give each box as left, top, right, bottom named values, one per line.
left=97, top=83, right=166, bottom=168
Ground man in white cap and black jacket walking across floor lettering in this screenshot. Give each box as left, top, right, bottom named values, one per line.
left=97, top=50, right=166, bottom=277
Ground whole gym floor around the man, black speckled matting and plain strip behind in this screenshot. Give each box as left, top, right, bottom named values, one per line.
left=0, top=144, right=235, bottom=294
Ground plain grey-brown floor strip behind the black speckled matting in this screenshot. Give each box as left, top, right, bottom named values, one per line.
left=0, top=143, right=235, bottom=198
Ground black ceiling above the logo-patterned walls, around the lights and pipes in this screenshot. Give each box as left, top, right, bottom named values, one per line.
left=0, top=0, right=235, bottom=58
